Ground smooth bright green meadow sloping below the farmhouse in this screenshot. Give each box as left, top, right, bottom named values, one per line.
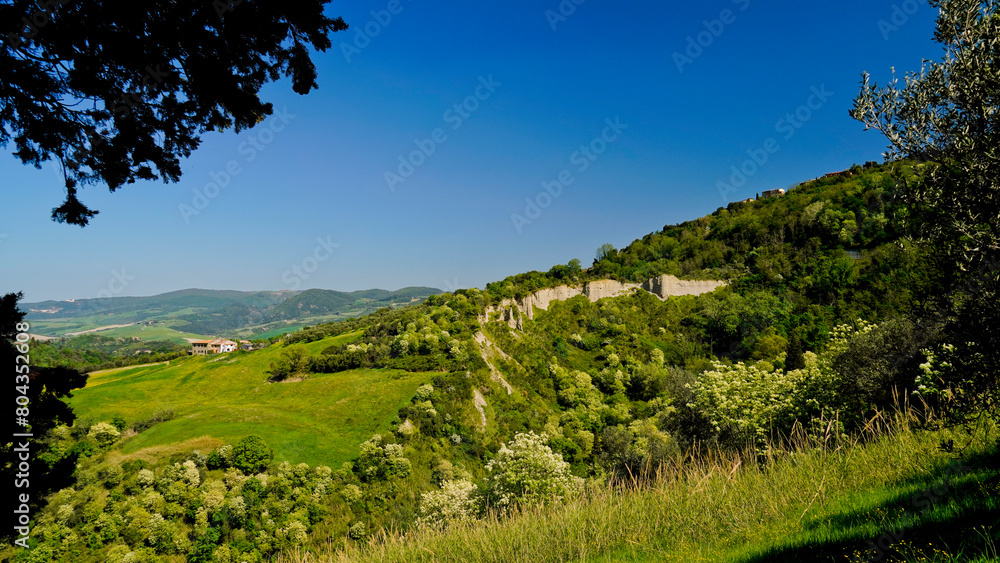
left=70, top=333, right=434, bottom=467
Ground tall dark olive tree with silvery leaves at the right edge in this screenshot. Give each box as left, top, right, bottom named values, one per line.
left=851, top=0, right=1000, bottom=424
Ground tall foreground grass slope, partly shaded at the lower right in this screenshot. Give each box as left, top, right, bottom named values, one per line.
left=283, top=416, right=1000, bottom=563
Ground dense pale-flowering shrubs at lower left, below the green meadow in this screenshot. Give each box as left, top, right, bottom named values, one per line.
left=13, top=434, right=345, bottom=563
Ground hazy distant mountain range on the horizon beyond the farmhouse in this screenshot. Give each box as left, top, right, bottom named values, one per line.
left=21, top=287, right=443, bottom=336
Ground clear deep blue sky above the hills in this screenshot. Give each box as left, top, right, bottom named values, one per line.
left=0, top=0, right=941, bottom=302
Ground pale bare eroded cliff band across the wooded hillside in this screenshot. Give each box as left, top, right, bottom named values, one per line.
left=486, top=275, right=726, bottom=330
